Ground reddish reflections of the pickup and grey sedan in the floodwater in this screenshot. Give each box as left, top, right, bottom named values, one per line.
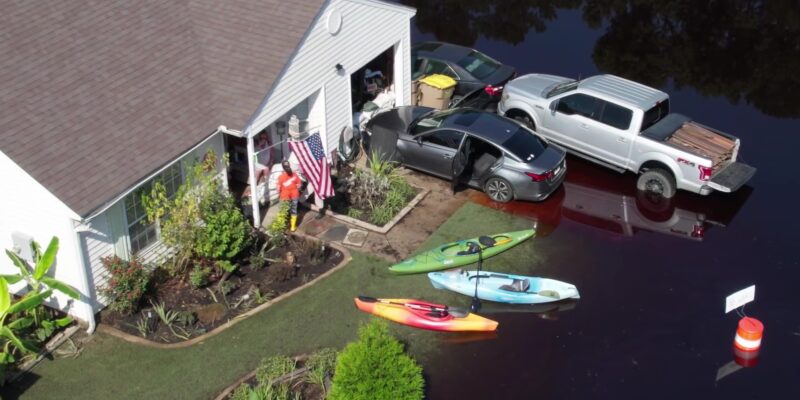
left=471, top=157, right=752, bottom=241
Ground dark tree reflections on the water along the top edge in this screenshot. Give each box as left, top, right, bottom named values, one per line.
left=404, top=0, right=800, bottom=118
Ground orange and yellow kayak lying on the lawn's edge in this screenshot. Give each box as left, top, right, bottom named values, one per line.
left=354, top=296, right=497, bottom=332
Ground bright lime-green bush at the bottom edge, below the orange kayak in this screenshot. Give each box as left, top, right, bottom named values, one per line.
left=329, top=319, right=425, bottom=400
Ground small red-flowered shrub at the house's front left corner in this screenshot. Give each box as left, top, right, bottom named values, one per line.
left=100, top=256, right=150, bottom=314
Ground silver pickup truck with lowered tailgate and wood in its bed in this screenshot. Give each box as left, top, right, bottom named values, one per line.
left=497, top=74, right=756, bottom=198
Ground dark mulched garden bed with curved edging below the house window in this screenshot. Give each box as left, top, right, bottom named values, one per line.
left=99, top=236, right=343, bottom=343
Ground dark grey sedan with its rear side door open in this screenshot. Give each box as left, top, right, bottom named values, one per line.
left=367, top=106, right=566, bottom=203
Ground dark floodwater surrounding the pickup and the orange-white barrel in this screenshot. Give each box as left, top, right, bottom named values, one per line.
left=406, top=0, right=800, bottom=399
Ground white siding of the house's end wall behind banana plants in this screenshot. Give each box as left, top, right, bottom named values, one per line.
left=0, top=152, right=90, bottom=320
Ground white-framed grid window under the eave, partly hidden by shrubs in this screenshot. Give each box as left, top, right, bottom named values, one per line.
left=125, top=162, right=183, bottom=254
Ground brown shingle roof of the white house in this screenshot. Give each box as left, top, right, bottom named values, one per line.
left=0, top=0, right=325, bottom=216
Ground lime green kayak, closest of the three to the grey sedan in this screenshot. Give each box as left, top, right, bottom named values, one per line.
left=389, top=229, right=536, bottom=274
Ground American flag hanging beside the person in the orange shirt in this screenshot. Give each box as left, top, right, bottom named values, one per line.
left=289, top=132, right=333, bottom=199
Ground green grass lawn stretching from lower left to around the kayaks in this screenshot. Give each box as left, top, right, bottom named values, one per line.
left=3, top=203, right=541, bottom=399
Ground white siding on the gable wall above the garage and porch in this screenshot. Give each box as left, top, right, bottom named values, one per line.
left=246, top=0, right=413, bottom=153
